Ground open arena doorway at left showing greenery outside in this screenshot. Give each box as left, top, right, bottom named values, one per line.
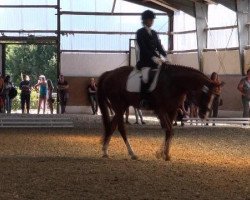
left=3, top=43, right=58, bottom=114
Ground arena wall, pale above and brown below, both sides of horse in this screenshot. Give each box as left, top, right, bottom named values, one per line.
left=61, top=50, right=246, bottom=113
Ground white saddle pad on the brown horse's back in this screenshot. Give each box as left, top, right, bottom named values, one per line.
left=127, top=67, right=160, bottom=92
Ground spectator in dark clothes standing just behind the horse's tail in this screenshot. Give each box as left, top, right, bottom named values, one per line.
left=88, top=78, right=98, bottom=115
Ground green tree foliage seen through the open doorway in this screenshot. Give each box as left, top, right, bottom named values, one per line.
left=6, top=45, right=57, bottom=86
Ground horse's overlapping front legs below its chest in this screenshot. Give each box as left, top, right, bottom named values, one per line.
left=156, top=114, right=173, bottom=161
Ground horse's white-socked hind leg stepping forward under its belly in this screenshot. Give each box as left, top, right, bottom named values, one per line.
left=118, top=112, right=138, bottom=160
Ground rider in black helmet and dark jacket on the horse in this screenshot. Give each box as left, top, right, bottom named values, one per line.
left=136, top=10, right=168, bottom=107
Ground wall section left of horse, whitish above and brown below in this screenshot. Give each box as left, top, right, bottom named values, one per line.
left=61, top=53, right=129, bottom=113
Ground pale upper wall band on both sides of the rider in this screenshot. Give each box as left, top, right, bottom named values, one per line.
left=61, top=50, right=245, bottom=77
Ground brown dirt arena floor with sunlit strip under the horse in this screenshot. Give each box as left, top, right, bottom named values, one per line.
left=0, top=128, right=250, bottom=200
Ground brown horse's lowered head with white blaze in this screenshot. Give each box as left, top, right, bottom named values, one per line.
left=198, top=82, right=219, bottom=119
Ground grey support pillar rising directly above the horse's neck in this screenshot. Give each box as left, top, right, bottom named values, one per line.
left=195, top=2, right=208, bottom=72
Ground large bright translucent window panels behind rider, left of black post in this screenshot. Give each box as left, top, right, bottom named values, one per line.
left=61, top=0, right=168, bottom=51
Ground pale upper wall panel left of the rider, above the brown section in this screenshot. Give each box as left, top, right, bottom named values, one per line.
left=61, top=53, right=129, bottom=77
